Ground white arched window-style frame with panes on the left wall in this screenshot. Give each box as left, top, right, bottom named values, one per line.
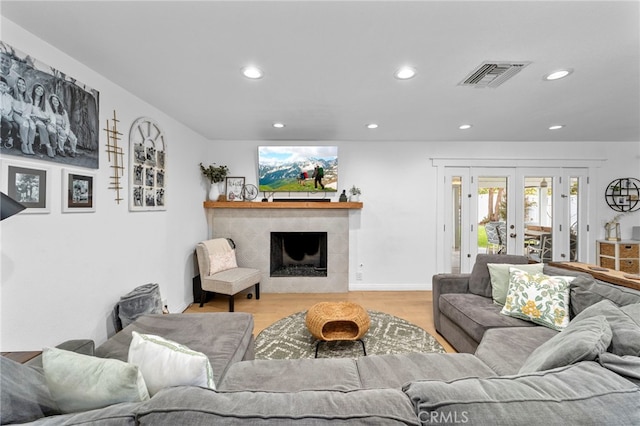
left=129, top=117, right=167, bottom=211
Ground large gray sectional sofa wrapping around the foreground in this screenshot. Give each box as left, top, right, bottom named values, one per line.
left=0, top=256, right=640, bottom=425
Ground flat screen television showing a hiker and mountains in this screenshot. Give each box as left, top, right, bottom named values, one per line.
left=258, top=146, right=338, bottom=192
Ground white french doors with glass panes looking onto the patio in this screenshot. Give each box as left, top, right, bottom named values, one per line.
left=437, top=167, right=588, bottom=273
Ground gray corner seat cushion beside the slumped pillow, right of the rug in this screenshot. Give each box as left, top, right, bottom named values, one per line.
left=475, top=326, right=559, bottom=376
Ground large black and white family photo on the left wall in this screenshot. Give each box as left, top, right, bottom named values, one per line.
left=0, top=42, right=99, bottom=169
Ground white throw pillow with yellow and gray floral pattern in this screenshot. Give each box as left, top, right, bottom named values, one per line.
left=500, top=268, right=574, bottom=330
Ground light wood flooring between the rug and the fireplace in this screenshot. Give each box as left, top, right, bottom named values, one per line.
left=184, top=291, right=455, bottom=352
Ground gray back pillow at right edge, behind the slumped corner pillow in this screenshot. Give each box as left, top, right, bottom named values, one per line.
left=572, top=299, right=640, bottom=356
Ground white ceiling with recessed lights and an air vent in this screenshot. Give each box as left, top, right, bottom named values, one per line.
left=1, top=0, right=640, bottom=142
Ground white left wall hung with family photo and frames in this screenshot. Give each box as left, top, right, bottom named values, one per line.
left=0, top=19, right=208, bottom=351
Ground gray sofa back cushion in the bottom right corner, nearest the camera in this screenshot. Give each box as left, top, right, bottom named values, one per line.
left=404, top=362, right=640, bottom=426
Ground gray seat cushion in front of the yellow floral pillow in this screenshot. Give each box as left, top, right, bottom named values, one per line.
left=438, top=293, right=535, bottom=342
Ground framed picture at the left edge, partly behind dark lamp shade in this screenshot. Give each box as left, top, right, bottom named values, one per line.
left=2, top=161, right=51, bottom=214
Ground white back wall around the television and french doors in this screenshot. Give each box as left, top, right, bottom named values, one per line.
left=210, top=141, right=640, bottom=290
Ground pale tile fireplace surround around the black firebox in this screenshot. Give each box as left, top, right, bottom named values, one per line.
left=205, top=202, right=361, bottom=293
